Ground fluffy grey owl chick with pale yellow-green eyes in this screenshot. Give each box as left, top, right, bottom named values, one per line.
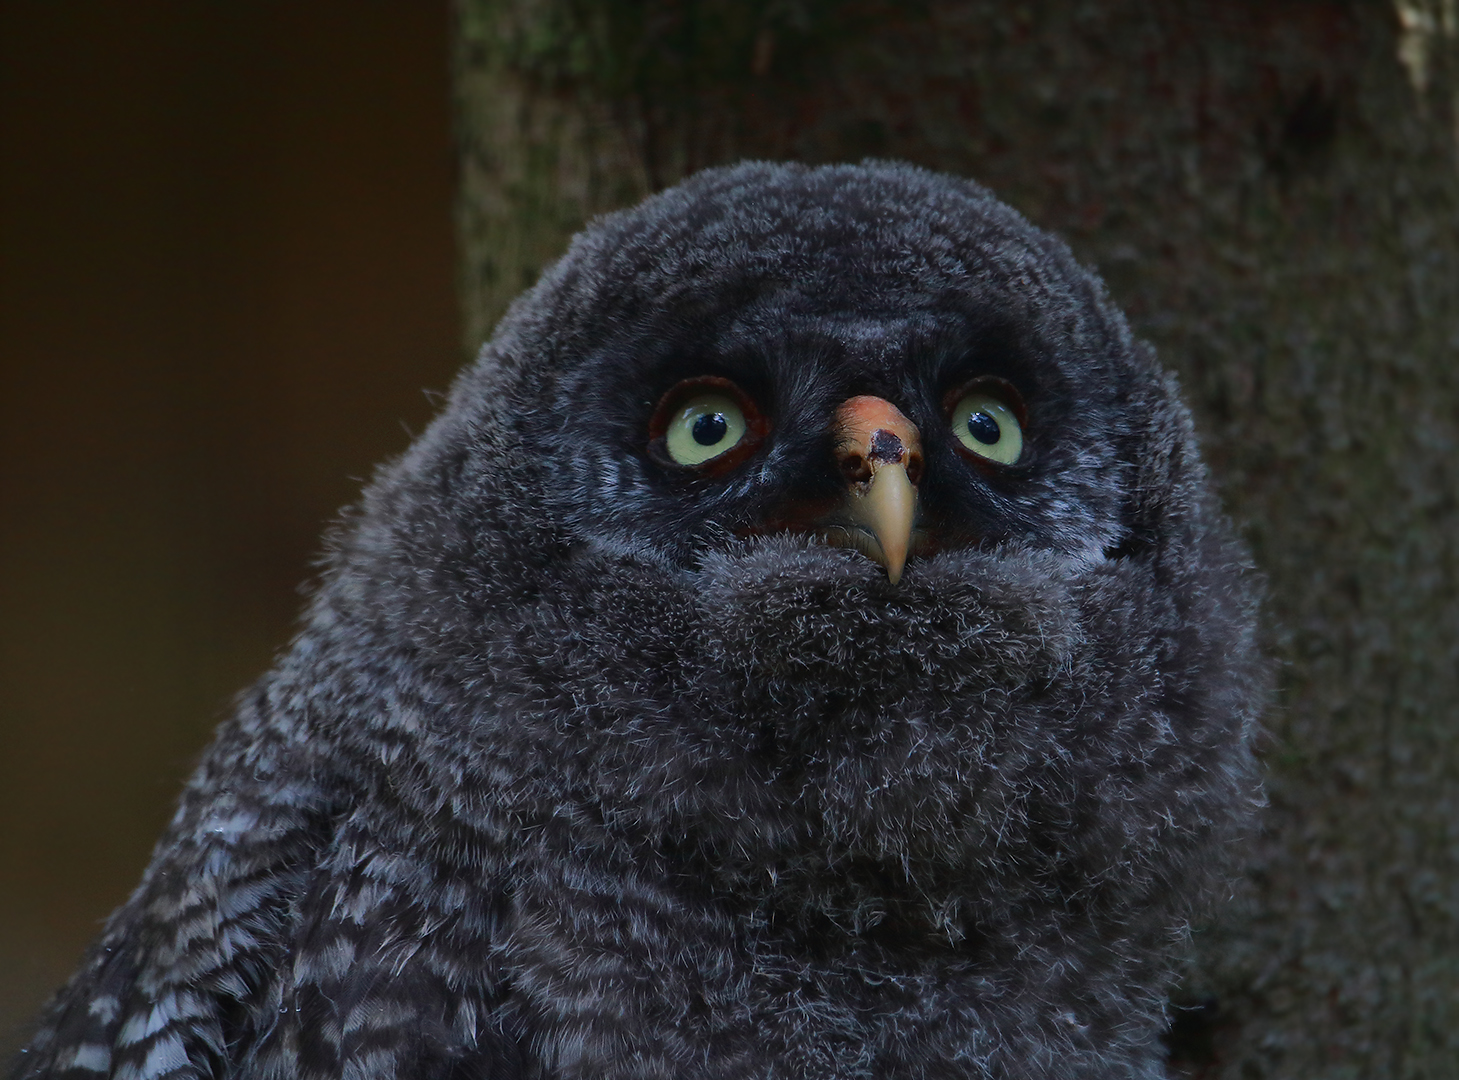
left=16, top=162, right=1265, bottom=1080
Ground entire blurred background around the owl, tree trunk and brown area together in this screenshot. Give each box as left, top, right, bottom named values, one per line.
left=0, top=0, right=1459, bottom=1080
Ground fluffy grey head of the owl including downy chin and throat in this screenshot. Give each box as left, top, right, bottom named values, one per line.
left=318, top=163, right=1263, bottom=952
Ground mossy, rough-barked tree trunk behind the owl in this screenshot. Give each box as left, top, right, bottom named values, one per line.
left=457, top=0, right=1459, bottom=1080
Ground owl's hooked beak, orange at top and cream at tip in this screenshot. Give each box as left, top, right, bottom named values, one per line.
left=826, top=396, right=922, bottom=585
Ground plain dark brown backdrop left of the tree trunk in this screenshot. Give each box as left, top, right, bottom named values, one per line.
left=0, top=1, right=461, bottom=1055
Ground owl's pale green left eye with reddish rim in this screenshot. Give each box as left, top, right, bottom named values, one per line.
left=649, top=375, right=769, bottom=474
